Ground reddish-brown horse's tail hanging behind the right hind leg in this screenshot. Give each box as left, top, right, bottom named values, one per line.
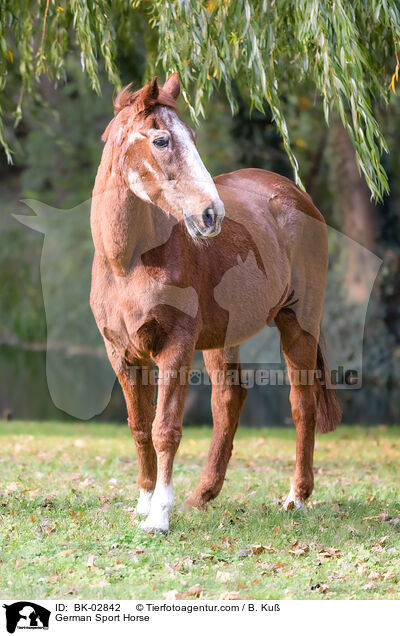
left=316, top=329, right=342, bottom=433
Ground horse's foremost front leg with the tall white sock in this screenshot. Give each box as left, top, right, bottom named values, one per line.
left=140, top=342, right=194, bottom=532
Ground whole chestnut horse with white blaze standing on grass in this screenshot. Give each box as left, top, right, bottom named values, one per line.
left=91, top=73, right=341, bottom=532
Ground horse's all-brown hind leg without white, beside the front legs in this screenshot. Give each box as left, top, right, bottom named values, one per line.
left=186, top=347, right=247, bottom=508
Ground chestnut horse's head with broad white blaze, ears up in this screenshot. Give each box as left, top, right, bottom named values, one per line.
left=103, top=73, right=225, bottom=238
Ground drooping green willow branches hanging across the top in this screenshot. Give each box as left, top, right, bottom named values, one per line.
left=0, top=0, right=400, bottom=199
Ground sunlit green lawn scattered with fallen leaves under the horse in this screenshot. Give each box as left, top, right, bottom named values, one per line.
left=0, top=422, right=400, bottom=599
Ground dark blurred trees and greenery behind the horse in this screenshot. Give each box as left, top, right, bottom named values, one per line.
left=0, top=2, right=400, bottom=425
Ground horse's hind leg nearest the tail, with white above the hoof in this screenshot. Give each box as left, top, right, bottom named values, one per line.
left=275, top=309, right=317, bottom=509
